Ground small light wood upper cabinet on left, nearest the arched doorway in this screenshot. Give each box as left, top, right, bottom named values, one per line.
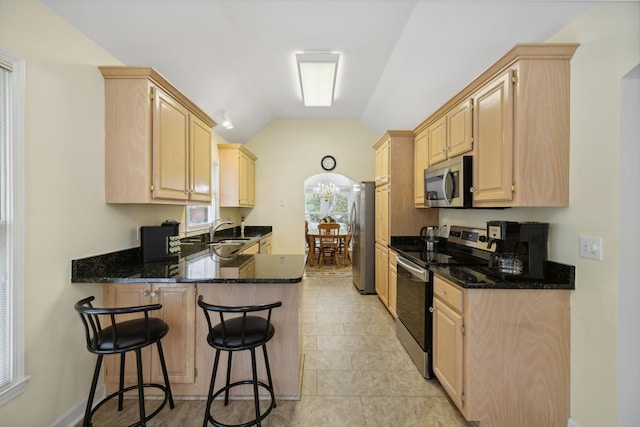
left=218, top=144, right=257, bottom=207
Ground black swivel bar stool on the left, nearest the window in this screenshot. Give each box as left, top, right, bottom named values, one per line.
left=75, top=296, right=174, bottom=427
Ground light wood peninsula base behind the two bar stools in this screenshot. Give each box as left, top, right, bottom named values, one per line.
left=105, top=282, right=302, bottom=400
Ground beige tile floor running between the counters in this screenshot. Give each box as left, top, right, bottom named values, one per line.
left=78, top=276, right=470, bottom=427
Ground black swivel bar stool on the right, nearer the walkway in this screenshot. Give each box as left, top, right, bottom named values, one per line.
left=198, top=295, right=282, bottom=427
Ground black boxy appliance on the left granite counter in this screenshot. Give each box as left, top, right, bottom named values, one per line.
left=140, top=220, right=180, bottom=262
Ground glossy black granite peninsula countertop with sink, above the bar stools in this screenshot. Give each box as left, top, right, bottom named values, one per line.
left=71, top=227, right=305, bottom=283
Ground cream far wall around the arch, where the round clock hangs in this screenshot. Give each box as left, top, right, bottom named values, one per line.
left=245, top=120, right=380, bottom=254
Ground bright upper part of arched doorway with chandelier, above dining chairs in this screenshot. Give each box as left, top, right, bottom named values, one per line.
left=304, top=173, right=353, bottom=229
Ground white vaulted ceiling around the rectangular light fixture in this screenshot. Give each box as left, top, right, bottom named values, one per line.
left=42, top=0, right=594, bottom=143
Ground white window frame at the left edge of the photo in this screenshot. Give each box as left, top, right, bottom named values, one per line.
left=0, top=49, right=29, bottom=406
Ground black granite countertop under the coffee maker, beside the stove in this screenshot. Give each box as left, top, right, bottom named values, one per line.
left=389, top=236, right=575, bottom=290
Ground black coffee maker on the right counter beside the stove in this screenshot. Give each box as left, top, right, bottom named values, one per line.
left=487, top=221, right=549, bottom=279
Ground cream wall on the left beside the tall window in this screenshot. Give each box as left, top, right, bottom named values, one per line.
left=0, top=0, right=183, bottom=427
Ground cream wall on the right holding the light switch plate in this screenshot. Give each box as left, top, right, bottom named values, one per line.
left=440, top=2, right=640, bottom=427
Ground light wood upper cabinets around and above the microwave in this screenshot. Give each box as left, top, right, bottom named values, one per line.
left=414, top=43, right=579, bottom=208
